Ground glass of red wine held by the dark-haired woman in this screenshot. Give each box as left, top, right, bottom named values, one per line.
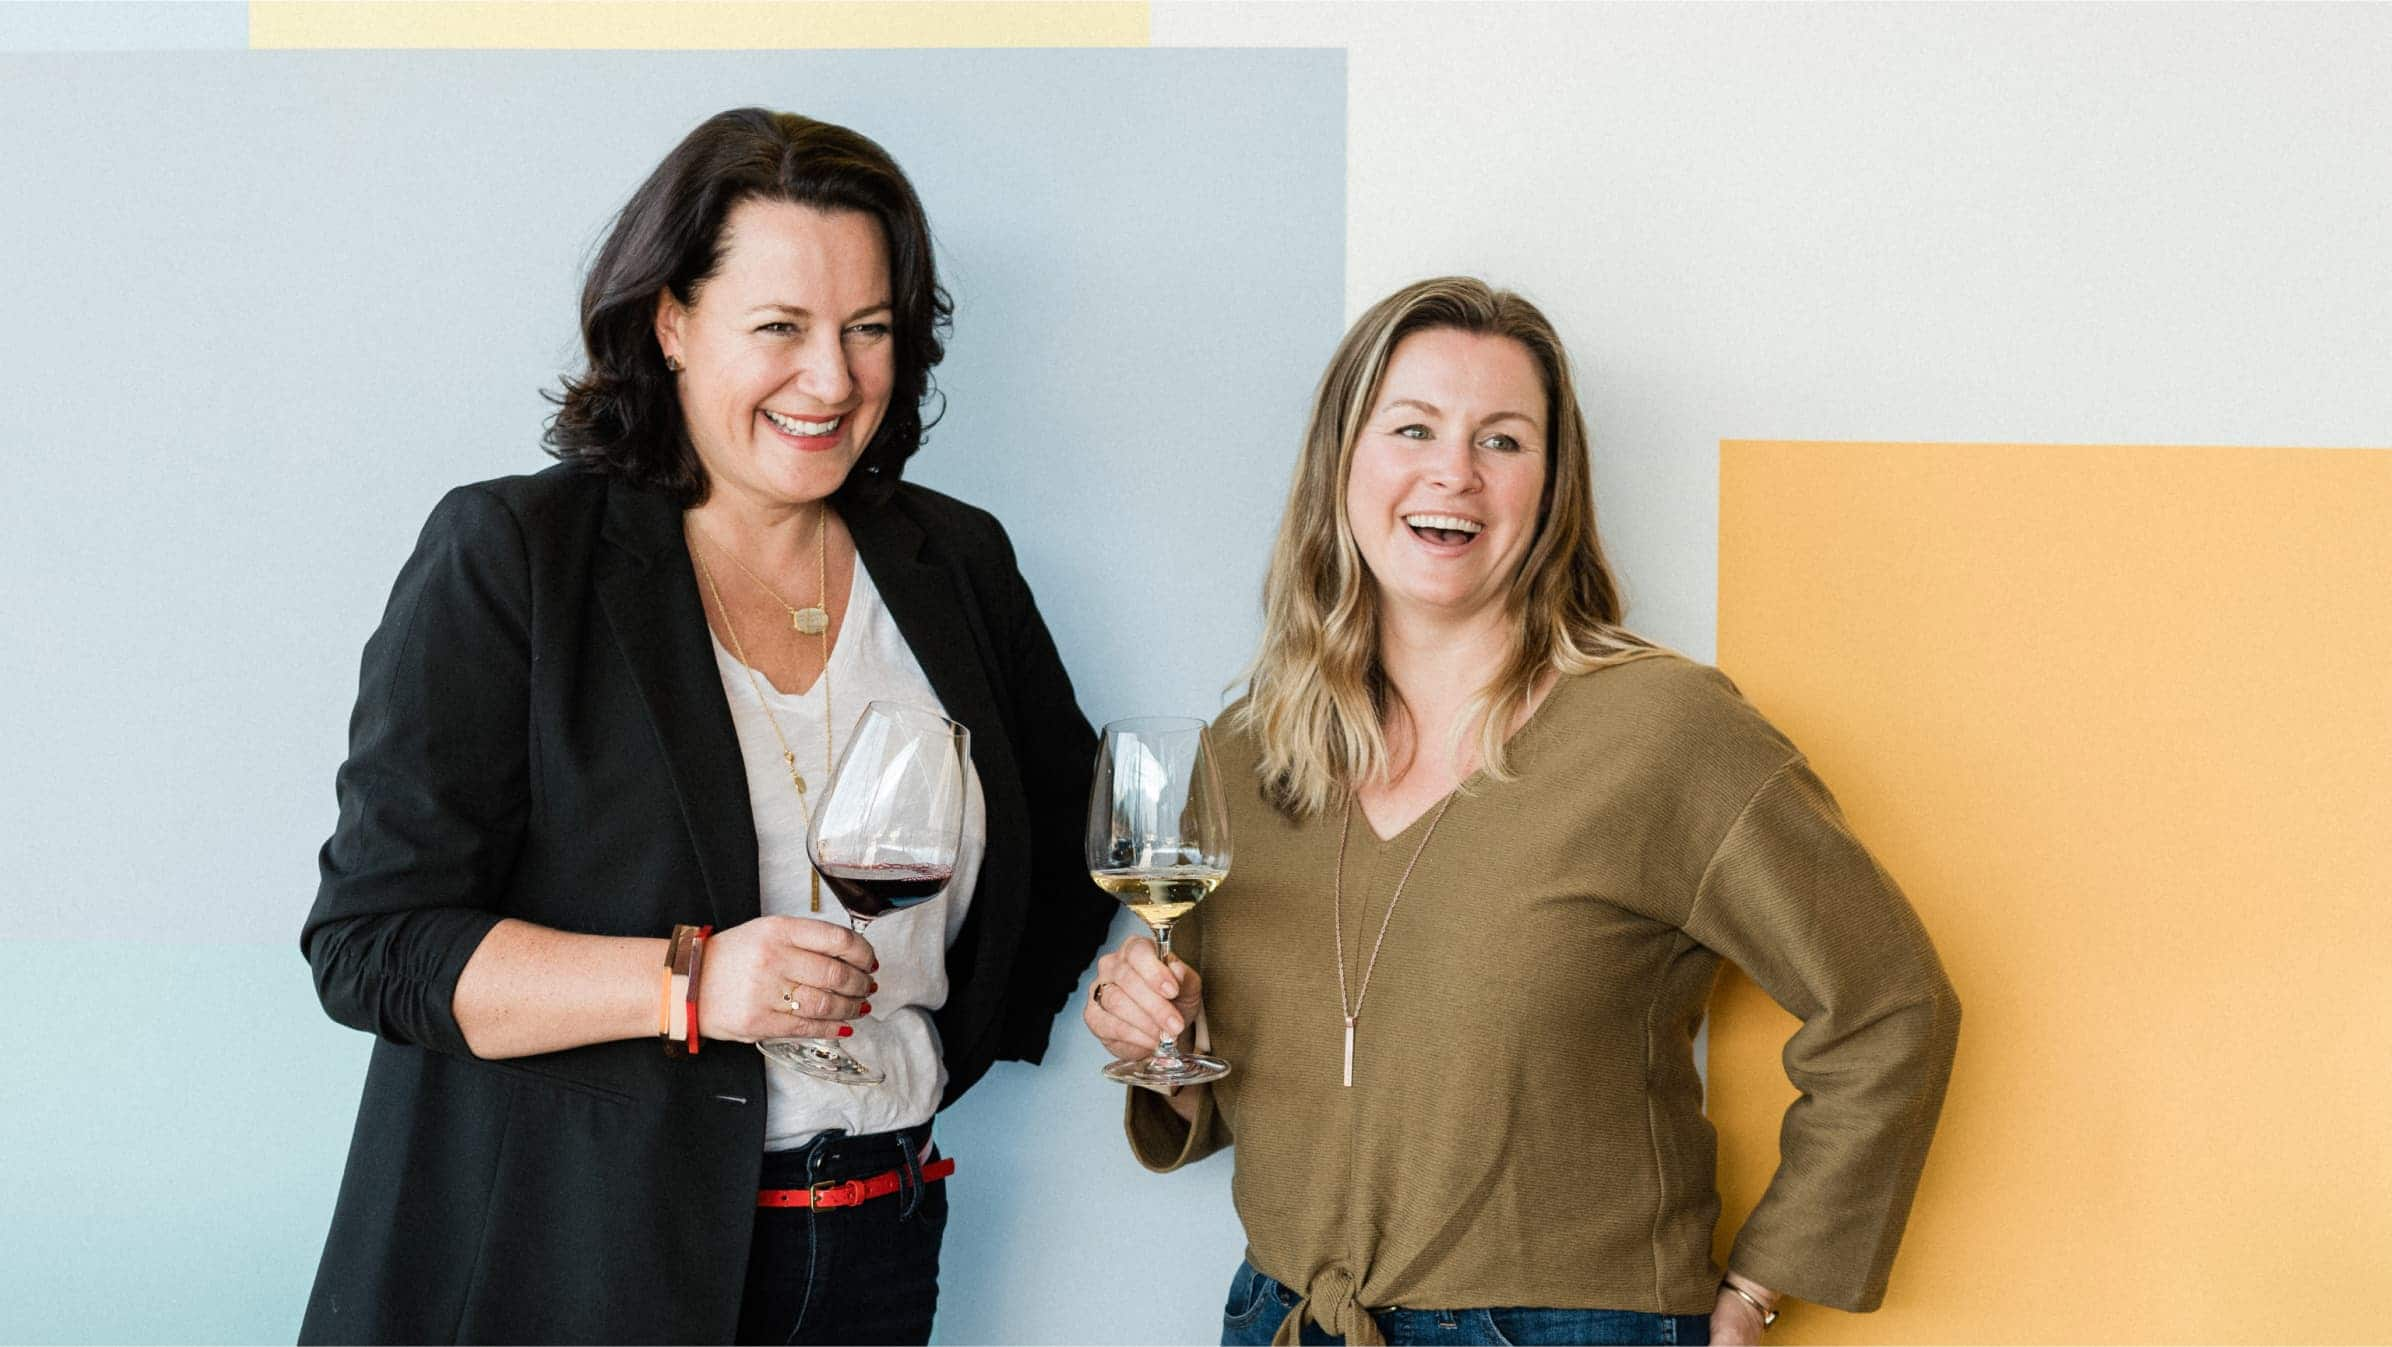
left=756, top=701, right=971, bottom=1086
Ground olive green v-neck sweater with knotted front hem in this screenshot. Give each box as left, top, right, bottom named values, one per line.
left=1129, top=656, right=1959, bottom=1342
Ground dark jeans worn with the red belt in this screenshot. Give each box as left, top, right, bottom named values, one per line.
left=739, top=1124, right=947, bottom=1345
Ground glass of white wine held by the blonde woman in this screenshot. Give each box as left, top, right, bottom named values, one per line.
left=1088, top=715, right=1229, bottom=1091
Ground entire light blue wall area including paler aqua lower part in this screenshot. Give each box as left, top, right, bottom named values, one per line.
left=0, top=50, right=1344, bottom=1342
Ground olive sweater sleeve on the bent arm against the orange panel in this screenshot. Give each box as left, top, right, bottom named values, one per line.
left=1686, top=758, right=1959, bottom=1311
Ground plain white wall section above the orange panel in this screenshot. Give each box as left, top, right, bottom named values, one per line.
left=1153, top=0, right=2392, bottom=672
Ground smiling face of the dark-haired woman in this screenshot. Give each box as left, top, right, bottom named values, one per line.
left=655, top=199, right=897, bottom=507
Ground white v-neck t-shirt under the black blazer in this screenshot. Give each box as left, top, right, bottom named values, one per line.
left=713, top=557, right=988, bottom=1151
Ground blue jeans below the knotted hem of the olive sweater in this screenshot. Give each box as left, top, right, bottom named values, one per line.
left=1220, top=1263, right=1710, bottom=1347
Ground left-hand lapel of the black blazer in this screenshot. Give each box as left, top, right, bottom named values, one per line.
left=598, top=483, right=758, bottom=928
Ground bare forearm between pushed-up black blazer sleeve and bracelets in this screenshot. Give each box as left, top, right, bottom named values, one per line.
left=450, top=919, right=665, bottom=1058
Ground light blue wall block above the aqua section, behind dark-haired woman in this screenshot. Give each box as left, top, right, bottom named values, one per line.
left=0, top=53, right=1344, bottom=940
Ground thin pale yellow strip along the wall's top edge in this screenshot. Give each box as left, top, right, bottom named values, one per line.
left=249, top=0, right=1148, bottom=50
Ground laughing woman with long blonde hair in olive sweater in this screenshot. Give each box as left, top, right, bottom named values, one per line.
left=1086, top=278, right=1959, bottom=1342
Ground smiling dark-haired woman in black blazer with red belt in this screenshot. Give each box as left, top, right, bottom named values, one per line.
left=301, top=108, right=1112, bottom=1342
